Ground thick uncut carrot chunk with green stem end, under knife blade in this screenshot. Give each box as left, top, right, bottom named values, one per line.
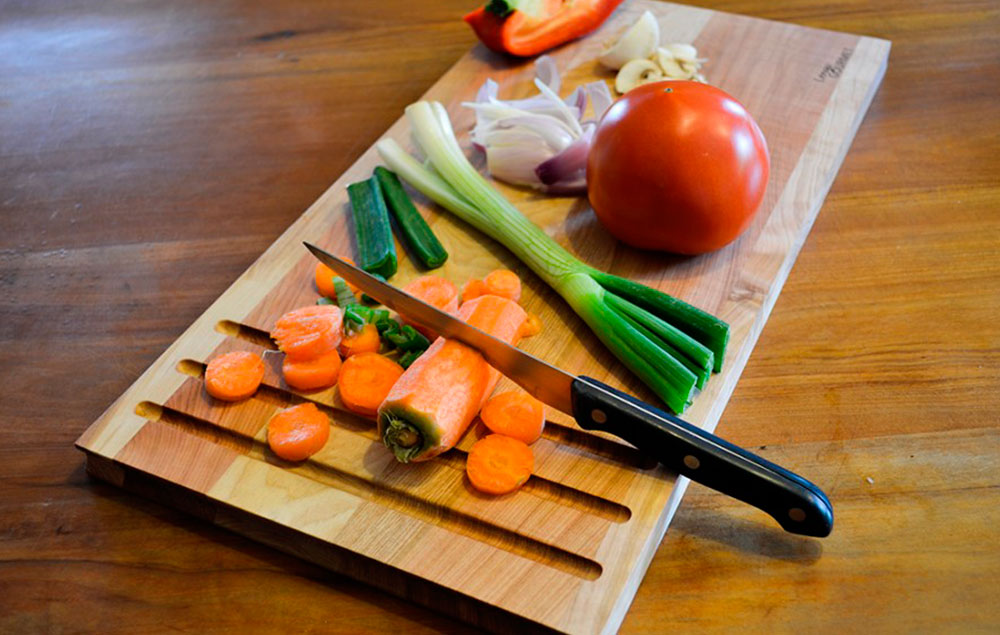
left=376, top=295, right=526, bottom=463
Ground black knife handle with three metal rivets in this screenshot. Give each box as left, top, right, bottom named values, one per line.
left=572, top=377, right=833, bottom=538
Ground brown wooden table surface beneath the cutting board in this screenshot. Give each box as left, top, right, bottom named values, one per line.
left=0, top=0, right=1000, bottom=633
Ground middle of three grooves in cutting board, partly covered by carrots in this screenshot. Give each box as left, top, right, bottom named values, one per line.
left=177, top=359, right=632, bottom=523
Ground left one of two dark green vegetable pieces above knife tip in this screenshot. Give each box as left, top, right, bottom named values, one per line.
left=347, top=177, right=396, bottom=279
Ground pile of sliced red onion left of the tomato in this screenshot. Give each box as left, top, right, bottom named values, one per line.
left=464, top=55, right=612, bottom=195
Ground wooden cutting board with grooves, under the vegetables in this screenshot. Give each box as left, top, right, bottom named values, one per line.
left=77, top=1, right=889, bottom=633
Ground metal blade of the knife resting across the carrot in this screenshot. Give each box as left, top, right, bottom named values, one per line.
left=304, top=243, right=576, bottom=416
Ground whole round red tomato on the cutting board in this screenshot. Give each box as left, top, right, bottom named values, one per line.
left=587, top=81, right=770, bottom=254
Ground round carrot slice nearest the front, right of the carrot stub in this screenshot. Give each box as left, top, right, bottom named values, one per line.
left=465, top=434, right=535, bottom=494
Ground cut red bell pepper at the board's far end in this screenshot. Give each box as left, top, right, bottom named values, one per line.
left=464, top=0, right=622, bottom=57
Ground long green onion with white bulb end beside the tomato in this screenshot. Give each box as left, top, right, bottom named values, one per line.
left=377, top=102, right=729, bottom=413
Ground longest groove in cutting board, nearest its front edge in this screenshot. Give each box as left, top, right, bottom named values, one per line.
left=135, top=401, right=603, bottom=581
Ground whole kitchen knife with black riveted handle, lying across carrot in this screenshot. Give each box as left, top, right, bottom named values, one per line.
left=304, top=243, right=833, bottom=538
